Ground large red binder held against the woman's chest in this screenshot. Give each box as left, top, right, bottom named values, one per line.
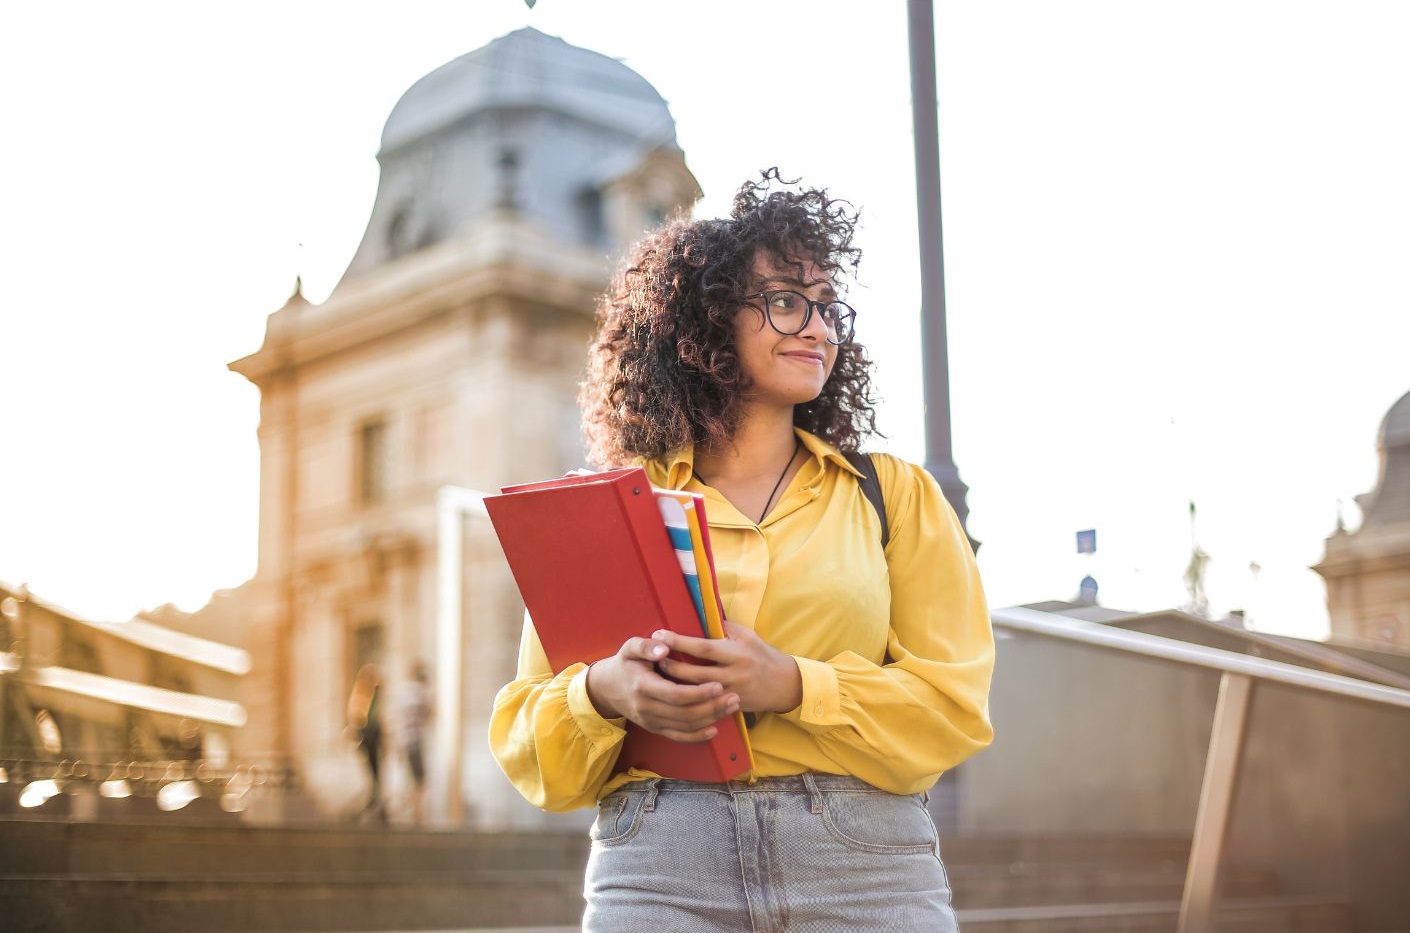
left=485, top=467, right=752, bottom=781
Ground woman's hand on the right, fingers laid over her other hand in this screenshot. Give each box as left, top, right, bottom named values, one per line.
left=651, top=622, right=802, bottom=713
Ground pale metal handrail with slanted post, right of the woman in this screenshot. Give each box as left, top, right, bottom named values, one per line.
left=990, top=607, right=1410, bottom=933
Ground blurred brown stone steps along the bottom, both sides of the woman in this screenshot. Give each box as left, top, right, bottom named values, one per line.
left=0, top=816, right=1355, bottom=933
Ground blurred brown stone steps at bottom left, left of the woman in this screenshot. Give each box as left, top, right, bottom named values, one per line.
left=0, top=819, right=587, bottom=933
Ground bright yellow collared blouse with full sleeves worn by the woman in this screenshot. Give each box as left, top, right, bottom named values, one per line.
left=489, top=431, right=994, bottom=810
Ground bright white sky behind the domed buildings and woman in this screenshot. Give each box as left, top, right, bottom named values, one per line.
left=0, top=0, right=1410, bottom=634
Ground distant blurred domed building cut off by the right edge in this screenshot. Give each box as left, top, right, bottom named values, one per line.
left=1313, top=392, right=1410, bottom=650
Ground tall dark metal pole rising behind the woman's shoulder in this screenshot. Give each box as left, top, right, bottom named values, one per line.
left=908, top=0, right=979, bottom=548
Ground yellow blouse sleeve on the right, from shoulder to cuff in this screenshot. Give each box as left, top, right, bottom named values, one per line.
left=784, top=455, right=994, bottom=793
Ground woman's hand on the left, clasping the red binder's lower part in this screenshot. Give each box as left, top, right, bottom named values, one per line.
left=588, top=638, right=739, bottom=741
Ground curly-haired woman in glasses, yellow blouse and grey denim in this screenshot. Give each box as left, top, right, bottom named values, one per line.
left=491, top=169, right=994, bottom=933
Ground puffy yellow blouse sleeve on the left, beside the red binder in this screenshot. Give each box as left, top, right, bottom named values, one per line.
left=489, top=617, right=626, bottom=812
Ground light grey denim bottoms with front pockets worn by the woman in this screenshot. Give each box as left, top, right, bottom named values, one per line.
left=582, top=774, right=959, bottom=933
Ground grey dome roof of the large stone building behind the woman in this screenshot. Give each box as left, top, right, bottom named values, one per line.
left=337, top=28, right=699, bottom=292
